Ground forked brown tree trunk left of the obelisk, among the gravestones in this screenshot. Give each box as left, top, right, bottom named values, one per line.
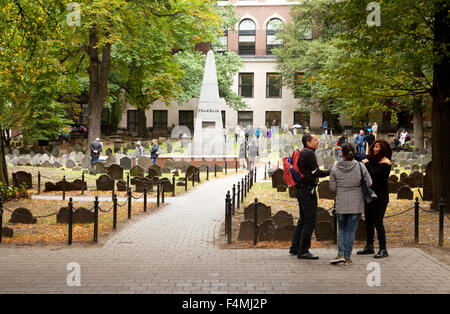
left=88, top=27, right=111, bottom=146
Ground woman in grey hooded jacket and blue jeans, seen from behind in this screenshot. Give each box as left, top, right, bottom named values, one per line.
left=330, top=143, right=372, bottom=266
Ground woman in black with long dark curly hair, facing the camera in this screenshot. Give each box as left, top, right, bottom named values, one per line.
left=358, top=140, right=392, bottom=258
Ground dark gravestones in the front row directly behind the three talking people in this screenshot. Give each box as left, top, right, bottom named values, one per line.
left=238, top=203, right=366, bottom=242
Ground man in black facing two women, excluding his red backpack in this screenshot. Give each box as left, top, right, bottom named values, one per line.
left=289, top=133, right=330, bottom=259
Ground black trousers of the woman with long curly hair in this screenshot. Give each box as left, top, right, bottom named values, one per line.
left=364, top=199, right=388, bottom=249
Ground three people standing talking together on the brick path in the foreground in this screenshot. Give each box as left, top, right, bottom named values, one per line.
left=289, top=133, right=392, bottom=265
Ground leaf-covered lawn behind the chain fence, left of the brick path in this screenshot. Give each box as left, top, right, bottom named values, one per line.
left=2, top=199, right=159, bottom=245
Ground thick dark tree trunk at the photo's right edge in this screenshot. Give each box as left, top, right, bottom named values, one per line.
left=432, top=1, right=450, bottom=212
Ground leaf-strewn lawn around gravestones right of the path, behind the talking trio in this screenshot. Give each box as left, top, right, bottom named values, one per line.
left=231, top=182, right=450, bottom=253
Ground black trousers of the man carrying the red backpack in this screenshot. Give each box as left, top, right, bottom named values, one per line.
left=290, top=185, right=317, bottom=255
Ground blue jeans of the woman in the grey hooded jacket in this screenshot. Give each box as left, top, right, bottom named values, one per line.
left=337, top=214, right=361, bottom=259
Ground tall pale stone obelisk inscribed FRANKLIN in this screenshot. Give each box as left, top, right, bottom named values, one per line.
left=194, top=50, right=224, bottom=156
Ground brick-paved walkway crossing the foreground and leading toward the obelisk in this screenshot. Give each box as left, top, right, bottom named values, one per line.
left=0, top=170, right=450, bottom=293
